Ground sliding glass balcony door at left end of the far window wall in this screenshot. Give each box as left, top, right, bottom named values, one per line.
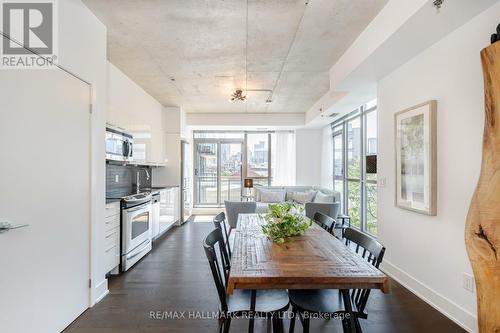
left=194, top=139, right=243, bottom=206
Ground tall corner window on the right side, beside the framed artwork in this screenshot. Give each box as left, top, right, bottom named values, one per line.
left=332, top=101, right=377, bottom=235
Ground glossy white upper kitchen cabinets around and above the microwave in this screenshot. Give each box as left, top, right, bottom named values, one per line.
left=106, top=62, right=166, bottom=166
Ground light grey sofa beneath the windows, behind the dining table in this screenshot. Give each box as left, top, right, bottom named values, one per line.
left=254, top=186, right=340, bottom=219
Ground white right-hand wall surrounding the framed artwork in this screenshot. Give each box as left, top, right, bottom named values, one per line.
left=378, top=4, right=500, bottom=331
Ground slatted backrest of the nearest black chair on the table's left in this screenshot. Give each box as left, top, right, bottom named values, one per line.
left=203, top=229, right=231, bottom=311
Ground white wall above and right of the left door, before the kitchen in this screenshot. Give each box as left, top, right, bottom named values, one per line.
left=57, top=0, right=107, bottom=304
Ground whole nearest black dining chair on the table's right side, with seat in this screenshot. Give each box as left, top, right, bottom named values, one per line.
left=288, top=228, right=385, bottom=333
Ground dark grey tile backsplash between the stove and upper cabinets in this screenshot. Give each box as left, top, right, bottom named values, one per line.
left=106, top=163, right=152, bottom=198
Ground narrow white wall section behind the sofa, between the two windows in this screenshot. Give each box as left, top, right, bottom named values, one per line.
left=295, top=129, right=322, bottom=186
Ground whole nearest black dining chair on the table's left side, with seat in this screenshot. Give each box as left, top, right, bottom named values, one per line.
left=203, top=229, right=289, bottom=333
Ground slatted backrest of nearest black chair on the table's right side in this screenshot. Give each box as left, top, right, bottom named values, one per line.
left=344, top=228, right=385, bottom=316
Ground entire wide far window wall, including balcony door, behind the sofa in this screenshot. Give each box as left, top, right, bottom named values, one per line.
left=193, top=131, right=295, bottom=207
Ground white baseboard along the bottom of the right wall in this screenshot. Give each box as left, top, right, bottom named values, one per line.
left=381, top=260, right=477, bottom=333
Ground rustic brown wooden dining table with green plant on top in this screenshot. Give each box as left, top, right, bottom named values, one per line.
left=227, top=214, right=389, bottom=332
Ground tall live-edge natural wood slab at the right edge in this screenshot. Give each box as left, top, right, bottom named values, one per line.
left=465, top=42, right=500, bottom=333
